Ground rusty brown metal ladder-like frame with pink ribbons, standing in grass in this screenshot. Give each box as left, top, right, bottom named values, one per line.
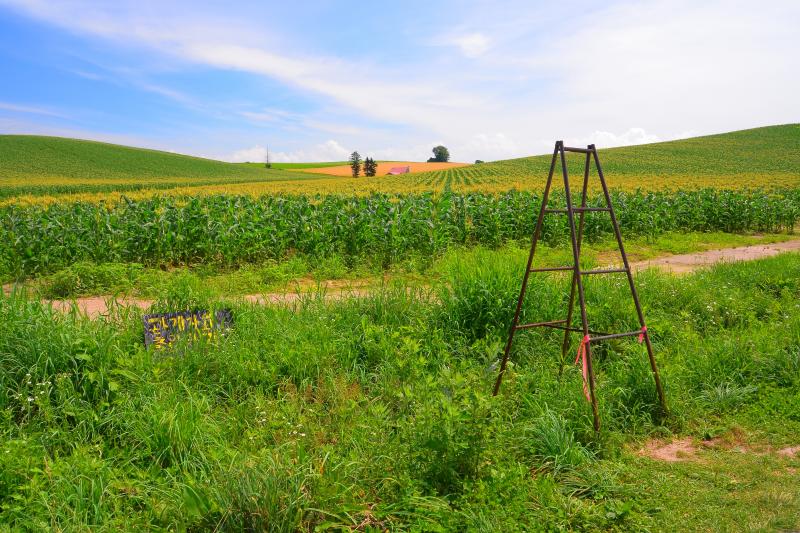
left=493, top=141, right=667, bottom=431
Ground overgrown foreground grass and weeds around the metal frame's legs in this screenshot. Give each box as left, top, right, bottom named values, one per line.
left=0, top=250, right=800, bottom=532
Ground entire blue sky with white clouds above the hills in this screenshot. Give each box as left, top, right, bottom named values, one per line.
left=0, top=0, right=800, bottom=161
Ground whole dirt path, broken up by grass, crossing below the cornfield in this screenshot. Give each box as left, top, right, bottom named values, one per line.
left=3, top=239, right=800, bottom=318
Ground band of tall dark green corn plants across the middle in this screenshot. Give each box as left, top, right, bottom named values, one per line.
left=0, top=189, right=800, bottom=279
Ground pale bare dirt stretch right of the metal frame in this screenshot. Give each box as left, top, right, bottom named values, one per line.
left=631, top=239, right=800, bottom=274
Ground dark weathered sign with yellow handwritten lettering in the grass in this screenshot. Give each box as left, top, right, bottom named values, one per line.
left=144, top=309, right=233, bottom=350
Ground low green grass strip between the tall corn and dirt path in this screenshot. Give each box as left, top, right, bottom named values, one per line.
left=18, top=232, right=796, bottom=299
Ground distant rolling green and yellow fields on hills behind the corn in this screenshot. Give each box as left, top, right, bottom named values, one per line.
left=0, top=124, right=800, bottom=204
